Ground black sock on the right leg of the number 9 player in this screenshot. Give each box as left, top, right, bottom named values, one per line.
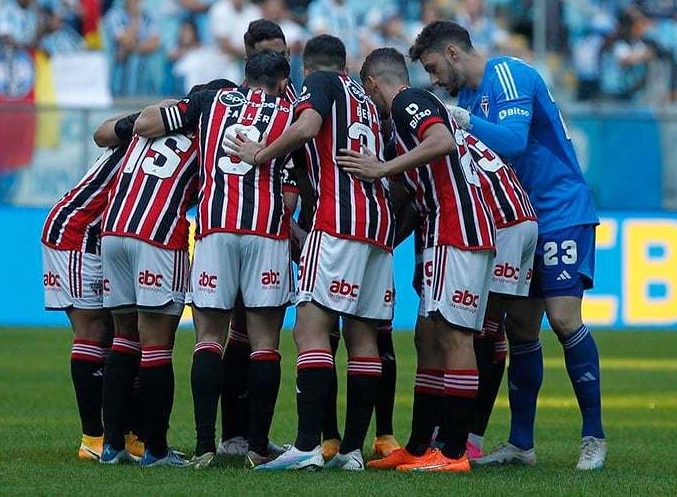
left=249, top=350, right=282, bottom=455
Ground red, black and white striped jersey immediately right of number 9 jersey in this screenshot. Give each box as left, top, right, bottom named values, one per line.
left=296, top=71, right=395, bottom=251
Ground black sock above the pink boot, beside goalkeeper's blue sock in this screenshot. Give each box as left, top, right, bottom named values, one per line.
left=470, top=334, right=503, bottom=436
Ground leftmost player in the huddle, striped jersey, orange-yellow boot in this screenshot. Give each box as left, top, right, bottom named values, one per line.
left=42, top=138, right=131, bottom=461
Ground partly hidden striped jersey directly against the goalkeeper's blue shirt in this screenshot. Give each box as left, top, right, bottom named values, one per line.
left=464, top=132, right=536, bottom=229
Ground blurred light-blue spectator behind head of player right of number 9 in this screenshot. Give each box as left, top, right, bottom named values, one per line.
left=308, top=0, right=361, bottom=61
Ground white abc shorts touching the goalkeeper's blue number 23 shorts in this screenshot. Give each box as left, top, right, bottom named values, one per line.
left=489, top=221, right=538, bottom=297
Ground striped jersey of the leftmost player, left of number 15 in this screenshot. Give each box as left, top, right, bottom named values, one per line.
left=42, top=146, right=126, bottom=254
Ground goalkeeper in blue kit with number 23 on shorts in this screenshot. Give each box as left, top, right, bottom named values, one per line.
left=410, top=22, right=607, bottom=470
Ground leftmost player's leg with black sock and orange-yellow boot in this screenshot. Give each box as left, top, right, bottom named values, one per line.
left=66, top=307, right=113, bottom=461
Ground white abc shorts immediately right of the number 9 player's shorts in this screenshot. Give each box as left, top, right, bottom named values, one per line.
left=296, top=231, right=395, bottom=321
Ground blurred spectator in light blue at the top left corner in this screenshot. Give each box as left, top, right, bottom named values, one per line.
left=0, top=0, right=38, bottom=49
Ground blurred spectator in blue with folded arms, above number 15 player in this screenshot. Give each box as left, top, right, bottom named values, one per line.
left=104, top=0, right=162, bottom=96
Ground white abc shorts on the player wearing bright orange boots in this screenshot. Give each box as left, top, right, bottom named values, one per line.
left=423, top=245, right=494, bottom=331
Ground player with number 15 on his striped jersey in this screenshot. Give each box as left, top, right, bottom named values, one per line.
left=101, top=89, right=207, bottom=466
